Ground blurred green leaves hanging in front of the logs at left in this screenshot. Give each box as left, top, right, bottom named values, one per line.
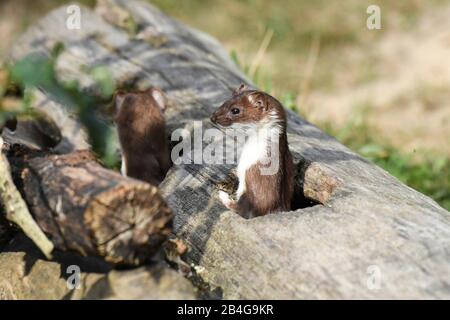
left=0, top=45, right=118, bottom=167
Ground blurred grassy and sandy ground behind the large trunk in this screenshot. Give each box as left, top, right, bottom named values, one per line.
left=0, top=0, right=450, bottom=210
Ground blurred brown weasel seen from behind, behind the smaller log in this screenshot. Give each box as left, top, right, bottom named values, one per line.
left=114, top=88, right=172, bottom=185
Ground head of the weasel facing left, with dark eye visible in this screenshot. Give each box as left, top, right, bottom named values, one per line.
left=211, top=85, right=286, bottom=127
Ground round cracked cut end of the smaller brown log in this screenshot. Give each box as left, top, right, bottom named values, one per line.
left=85, top=181, right=172, bottom=265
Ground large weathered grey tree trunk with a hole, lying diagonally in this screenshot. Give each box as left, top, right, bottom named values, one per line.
left=7, top=0, right=450, bottom=298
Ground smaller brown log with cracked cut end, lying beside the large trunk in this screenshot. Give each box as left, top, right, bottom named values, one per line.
left=8, top=145, right=172, bottom=265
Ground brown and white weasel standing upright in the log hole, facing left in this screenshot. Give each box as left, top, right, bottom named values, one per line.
left=211, top=85, right=294, bottom=218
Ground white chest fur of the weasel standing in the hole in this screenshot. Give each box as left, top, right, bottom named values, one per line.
left=236, top=122, right=280, bottom=199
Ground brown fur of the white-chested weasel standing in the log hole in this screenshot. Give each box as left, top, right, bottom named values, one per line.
left=211, top=86, right=294, bottom=218
